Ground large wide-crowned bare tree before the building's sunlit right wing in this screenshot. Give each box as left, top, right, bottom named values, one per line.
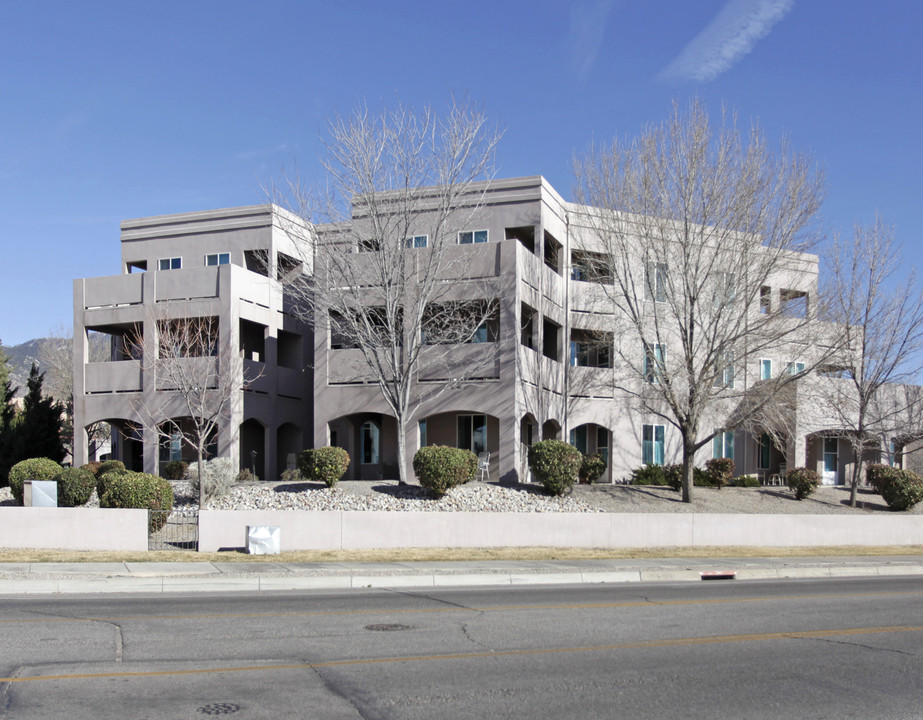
left=574, top=99, right=823, bottom=502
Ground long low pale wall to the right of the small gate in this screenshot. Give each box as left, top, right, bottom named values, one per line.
left=199, top=510, right=923, bottom=552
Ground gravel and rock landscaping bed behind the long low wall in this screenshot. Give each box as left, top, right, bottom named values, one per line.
left=0, top=480, right=923, bottom=515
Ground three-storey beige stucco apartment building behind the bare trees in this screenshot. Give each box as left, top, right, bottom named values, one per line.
left=74, top=176, right=908, bottom=483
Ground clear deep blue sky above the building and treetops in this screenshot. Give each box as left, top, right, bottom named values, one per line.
left=0, top=0, right=923, bottom=345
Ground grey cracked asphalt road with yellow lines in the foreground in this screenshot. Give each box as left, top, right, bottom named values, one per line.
left=0, top=578, right=923, bottom=720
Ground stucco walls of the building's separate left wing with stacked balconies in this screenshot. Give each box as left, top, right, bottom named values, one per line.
left=74, top=206, right=313, bottom=479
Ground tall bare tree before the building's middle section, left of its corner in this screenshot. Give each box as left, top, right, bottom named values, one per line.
left=276, top=102, right=501, bottom=481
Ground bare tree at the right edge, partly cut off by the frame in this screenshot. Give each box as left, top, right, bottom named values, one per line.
left=816, top=217, right=923, bottom=506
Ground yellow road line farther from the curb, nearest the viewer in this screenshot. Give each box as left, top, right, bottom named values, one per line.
left=0, top=625, right=923, bottom=683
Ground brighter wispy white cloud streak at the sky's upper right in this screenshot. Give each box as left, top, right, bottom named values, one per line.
left=660, top=0, right=795, bottom=82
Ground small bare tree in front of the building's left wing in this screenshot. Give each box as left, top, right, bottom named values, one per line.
left=127, top=308, right=258, bottom=503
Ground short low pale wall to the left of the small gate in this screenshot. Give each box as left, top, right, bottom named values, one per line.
left=0, top=507, right=147, bottom=551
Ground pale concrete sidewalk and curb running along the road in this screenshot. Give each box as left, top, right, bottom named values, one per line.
left=0, top=555, right=923, bottom=596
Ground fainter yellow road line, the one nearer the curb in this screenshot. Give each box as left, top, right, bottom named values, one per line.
left=0, top=590, right=923, bottom=625
